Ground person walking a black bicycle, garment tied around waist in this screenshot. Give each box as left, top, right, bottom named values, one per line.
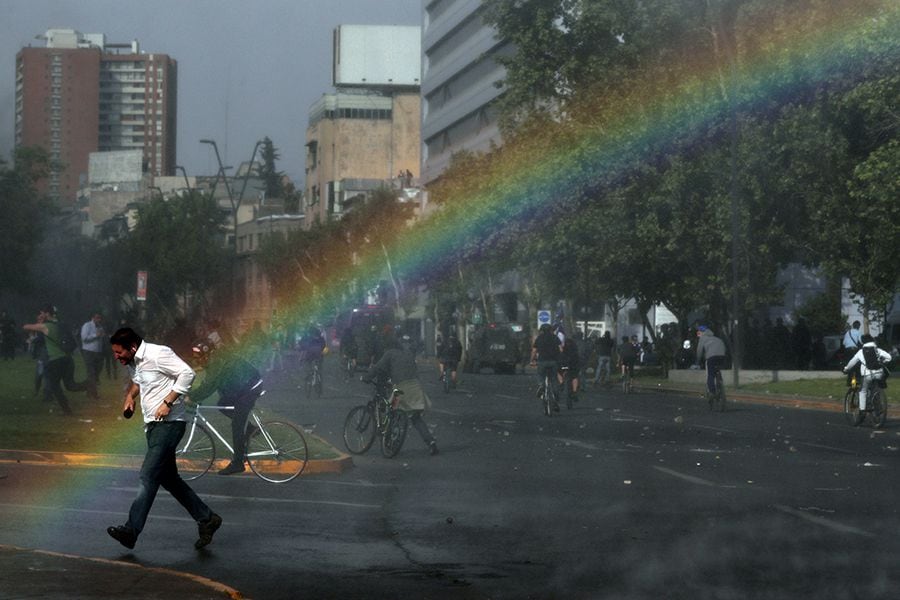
left=362, top=335, right=438, bottom=456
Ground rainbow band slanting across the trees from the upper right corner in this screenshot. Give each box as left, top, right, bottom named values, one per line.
left=243, top=0, right=900, bottom=344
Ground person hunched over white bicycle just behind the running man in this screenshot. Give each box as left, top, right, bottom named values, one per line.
left=191, top=342, right=263, bottom=475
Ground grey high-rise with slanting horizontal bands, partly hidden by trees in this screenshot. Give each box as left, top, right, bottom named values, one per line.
left=422, top=0, right=513, bottom=185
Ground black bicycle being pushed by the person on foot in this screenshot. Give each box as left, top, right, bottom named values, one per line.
left=344, top=380, right=409, bottom=458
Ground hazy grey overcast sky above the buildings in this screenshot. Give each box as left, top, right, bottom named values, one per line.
left=0, top=0, right=422, bottom=185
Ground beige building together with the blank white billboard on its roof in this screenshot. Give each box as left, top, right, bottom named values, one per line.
left=304, top=25, right=421, bottom=227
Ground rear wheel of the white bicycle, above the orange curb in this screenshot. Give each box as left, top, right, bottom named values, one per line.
left=247, top=421, right=309, bottom=483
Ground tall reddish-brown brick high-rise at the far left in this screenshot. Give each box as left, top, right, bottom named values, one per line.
left=15, top=29, right=178, bottom=206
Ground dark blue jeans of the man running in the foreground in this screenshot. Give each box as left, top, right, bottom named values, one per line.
left=125, top=421, right=213, bottom=535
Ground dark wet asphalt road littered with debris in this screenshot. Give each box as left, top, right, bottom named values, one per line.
left=0, top=358, right=900, bottom=599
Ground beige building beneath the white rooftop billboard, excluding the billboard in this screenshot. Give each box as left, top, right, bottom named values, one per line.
left=304, top=88, right=421, bottom=227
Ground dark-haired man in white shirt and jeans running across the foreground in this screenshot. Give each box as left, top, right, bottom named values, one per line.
left=106, top=327, right=222, bottom=549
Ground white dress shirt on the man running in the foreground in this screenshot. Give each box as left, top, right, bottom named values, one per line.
left=128, top=342, right=195, bottom=423
